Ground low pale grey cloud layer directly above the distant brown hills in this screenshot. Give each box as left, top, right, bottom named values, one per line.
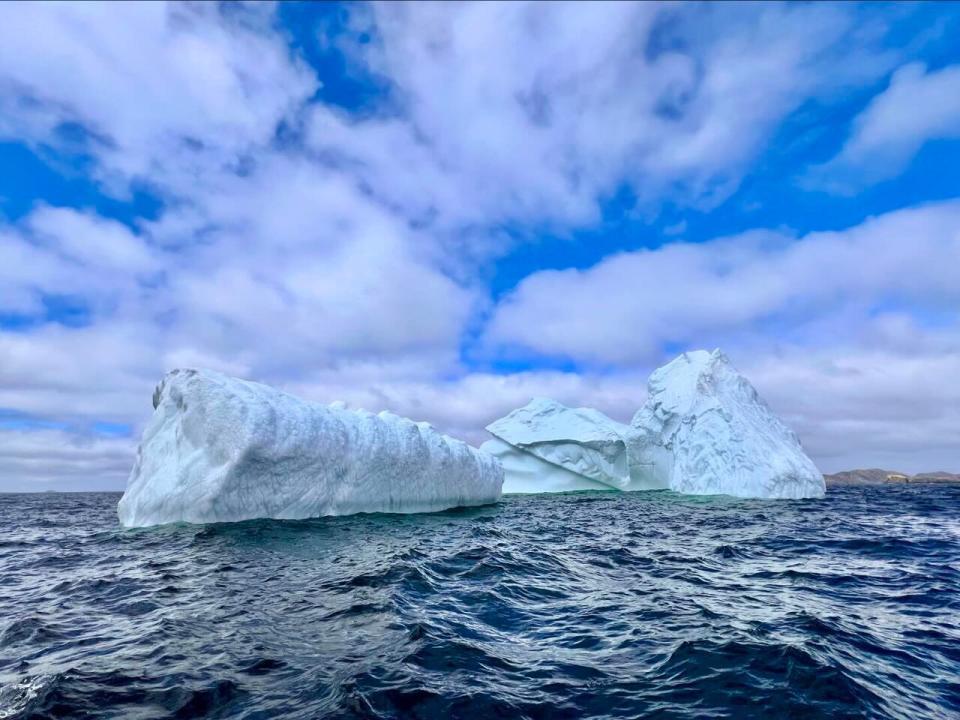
left=741, top=344, right=960, bottom=473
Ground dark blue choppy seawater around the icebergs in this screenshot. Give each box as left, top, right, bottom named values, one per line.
left=0, top=486, right=960, bottom=719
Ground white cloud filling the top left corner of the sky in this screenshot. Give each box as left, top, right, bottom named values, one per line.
left=0, top=2, right=317, bottom=189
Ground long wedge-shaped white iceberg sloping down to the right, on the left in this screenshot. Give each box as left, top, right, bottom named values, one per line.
left=118, top=370, right=503, bottom=527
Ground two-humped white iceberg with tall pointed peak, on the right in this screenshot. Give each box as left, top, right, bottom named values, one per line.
left=483, top=350, right=825, bottom=498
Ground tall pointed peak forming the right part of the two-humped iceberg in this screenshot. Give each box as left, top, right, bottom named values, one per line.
left=629, top=350, right=826, bottom=498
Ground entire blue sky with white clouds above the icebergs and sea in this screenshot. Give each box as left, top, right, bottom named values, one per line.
left=0, top=2, right=960, bottom=491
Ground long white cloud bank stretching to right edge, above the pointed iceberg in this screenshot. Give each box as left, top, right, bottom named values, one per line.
left=486, top=201, right=960, bottom=364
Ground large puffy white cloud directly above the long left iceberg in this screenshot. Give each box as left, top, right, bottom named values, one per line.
left=0, top=159, right=483, bottom=404
